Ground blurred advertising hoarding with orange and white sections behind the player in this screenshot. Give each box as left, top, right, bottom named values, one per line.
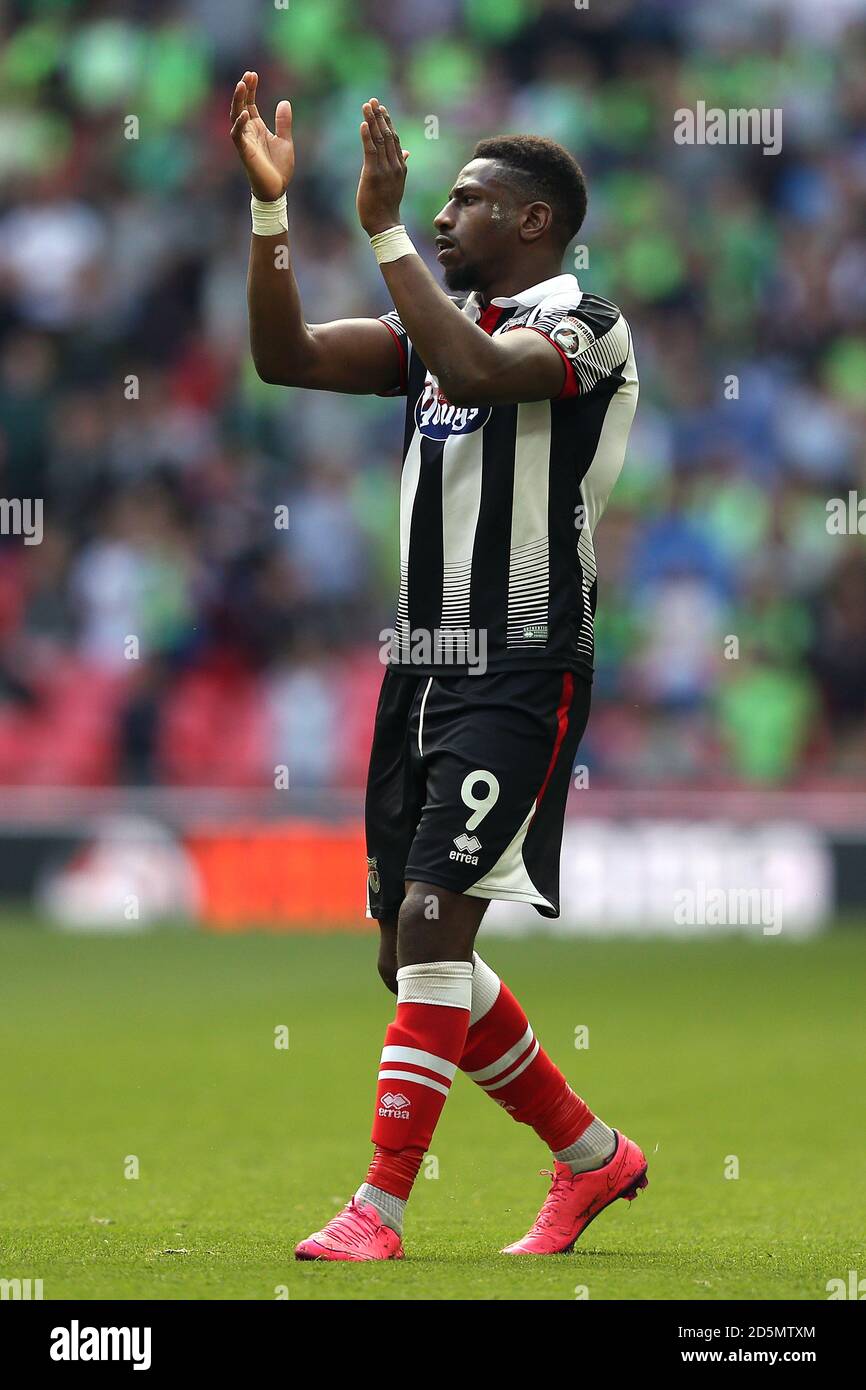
left=0, top=788, right=866, bottom=938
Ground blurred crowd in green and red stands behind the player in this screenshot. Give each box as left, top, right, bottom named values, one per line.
left=0, top=0, right=866, bottom=787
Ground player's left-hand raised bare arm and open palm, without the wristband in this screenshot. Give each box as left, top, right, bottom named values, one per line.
left=231, top=72, right=400, bottom=395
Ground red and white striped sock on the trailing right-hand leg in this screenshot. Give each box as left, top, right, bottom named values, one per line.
left=460, top=955, right=616, bottom=1173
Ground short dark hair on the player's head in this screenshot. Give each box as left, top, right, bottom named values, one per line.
left=473, top=135, right=587, bottom=249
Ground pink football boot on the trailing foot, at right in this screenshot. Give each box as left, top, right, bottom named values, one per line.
left=500, top=1130, right=649, bottom=1255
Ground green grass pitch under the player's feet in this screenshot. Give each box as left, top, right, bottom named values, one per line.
left=0, top=919, right=866, bottom=1300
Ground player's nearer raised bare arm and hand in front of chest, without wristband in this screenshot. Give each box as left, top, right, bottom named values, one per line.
left=357, top=99, right=569, bottom=406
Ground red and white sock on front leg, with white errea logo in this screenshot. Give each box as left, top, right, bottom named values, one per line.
left=354, top=960, right=473, bottom=1233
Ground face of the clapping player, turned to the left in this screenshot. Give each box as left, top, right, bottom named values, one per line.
left=434, top=160, right=516, bottom=291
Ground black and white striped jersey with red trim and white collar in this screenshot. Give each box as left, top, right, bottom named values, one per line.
left=382, top=275, right=638, bottom=676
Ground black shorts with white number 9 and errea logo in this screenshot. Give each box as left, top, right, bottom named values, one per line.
left=366, top=670, right=592, bottom=917
